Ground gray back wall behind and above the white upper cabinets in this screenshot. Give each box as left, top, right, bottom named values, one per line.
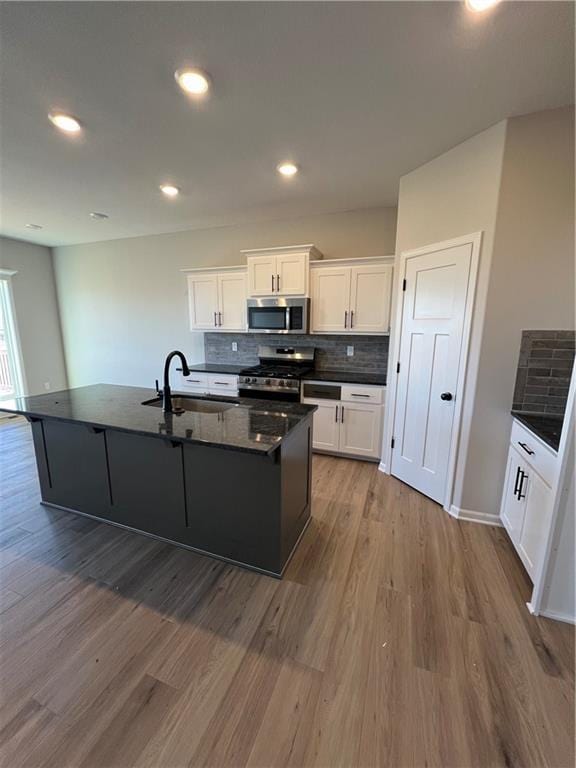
left=54, top=208, right=396, bottom=386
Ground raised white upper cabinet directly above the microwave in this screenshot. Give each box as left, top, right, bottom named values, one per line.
left=242, top=245, right=322, bottom=296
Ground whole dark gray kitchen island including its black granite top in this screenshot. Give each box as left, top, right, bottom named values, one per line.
left=2, top=385, right=314, bottom=577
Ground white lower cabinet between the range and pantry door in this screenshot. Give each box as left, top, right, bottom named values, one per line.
left=302, top=384, right=385, bottom=459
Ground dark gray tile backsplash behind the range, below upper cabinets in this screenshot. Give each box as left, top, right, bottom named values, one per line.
left=204, top=333, right=389, bottom=373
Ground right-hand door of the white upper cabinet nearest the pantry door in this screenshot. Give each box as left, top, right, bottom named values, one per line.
left=349, top=264, right=394, bottom=333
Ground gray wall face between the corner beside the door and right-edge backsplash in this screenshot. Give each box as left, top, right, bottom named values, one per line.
left=455, top=107, right=575, bottom=514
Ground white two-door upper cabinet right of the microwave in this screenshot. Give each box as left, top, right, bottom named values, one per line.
left=310, top=257, right=394, bottom=334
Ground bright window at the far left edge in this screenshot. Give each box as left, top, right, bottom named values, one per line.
left=0, top=270, right=24, bottom=400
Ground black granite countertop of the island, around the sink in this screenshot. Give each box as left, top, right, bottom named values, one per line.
left=0, top=384, right=316, bottom=455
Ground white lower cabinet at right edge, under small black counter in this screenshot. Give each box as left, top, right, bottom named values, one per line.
left=500, top=421, right=556, bottom=579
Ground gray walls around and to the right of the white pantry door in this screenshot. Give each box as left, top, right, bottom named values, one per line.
left=389, top=108, right=574, bottom=515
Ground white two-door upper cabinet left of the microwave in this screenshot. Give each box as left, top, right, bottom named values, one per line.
left=184, top=267, right=246, bottom=331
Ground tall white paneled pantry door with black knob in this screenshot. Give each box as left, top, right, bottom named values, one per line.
left=391, top=242, right=473, bottom=503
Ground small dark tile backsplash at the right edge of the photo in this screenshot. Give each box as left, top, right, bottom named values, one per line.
left=512, top=331, right=575, bottom=416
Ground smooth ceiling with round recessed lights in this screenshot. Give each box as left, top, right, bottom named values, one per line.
left=0, top=2, right=574, bottom=245
